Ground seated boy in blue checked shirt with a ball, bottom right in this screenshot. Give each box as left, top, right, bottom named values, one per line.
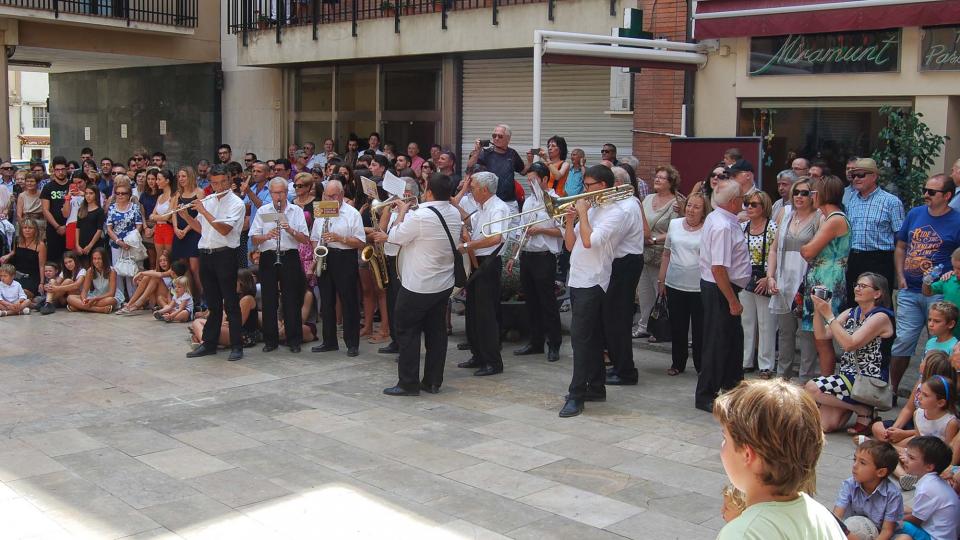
left=833, top=440, right=903, bottom=540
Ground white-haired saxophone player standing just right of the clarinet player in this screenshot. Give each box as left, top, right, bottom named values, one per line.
left=310, top=180, right=367, bottom=356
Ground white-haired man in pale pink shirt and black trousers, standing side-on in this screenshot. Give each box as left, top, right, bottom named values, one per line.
left=695, top=180, right=751, bottom=412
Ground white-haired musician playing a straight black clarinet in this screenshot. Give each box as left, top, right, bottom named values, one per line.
left=250, top=176, right=310, bottom=353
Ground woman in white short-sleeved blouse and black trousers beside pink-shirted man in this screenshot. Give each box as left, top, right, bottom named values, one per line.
left=657, top=191, right=711, bottom=376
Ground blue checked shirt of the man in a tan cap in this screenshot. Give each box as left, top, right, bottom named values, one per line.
left=846, top=187, right=904, bottom=251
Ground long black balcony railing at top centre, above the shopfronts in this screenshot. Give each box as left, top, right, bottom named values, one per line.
left=227, top=0, right=572, bottom=45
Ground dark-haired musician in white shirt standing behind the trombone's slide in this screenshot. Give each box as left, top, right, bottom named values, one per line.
left=507, top=161, right=563, bottom=362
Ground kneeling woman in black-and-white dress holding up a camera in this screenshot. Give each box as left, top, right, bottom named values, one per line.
left=805, top=272, right=894, bottom=435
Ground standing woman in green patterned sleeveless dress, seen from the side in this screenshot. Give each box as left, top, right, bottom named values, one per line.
left=800, top=176, right=850, bottom=377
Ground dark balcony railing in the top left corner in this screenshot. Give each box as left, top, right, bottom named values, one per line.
left=0, top=0, right=198, bottom=28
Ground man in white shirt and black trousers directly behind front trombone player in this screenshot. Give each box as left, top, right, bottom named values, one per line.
left=603, top=167, right=643, bottom=386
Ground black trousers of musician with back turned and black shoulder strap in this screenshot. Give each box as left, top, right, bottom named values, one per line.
left=391, top=287, right=453, bottom=390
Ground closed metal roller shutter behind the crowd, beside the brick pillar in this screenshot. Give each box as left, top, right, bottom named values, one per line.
left=460, top=58, right=633, bottom=175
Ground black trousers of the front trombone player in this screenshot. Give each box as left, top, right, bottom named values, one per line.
left=569, top=285, right=604, bottom=400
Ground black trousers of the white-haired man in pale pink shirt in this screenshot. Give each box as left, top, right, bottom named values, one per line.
left=692, top=279, right=743, bottom=408
